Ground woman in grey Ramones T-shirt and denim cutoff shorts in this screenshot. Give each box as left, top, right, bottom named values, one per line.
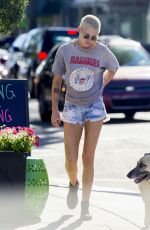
left=51, top=15, right=119, bottom=218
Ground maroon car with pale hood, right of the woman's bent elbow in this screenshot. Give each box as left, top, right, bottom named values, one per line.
left=100, top=36, right=150, bottom=118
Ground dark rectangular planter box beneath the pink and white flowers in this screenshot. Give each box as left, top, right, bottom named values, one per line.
left=0, top=152, right=31, bottom=223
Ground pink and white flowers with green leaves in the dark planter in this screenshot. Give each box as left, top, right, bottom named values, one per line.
left=0, top=125, right=39, bottom=152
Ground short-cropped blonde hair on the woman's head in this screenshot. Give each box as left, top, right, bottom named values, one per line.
left=80, top=14, right=101, bottom=33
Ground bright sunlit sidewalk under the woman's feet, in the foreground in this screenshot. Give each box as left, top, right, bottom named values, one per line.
left=0, top=182, right=144, bottom=230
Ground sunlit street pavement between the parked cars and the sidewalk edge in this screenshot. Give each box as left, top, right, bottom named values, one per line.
left=30, top=100, right=150, bottom=192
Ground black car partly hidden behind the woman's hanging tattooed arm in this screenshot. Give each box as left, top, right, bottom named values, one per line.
left=34, top=42, right=66, bottom=121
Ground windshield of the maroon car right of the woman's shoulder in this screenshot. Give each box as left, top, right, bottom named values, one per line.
left=110, top=45, right=150, bottom=66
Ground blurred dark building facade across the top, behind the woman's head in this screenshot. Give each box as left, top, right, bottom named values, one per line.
left=32, top=0, right=150, bottom=43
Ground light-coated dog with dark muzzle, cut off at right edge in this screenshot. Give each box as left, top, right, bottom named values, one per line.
left=127, top=153, right=150, bottom=229
